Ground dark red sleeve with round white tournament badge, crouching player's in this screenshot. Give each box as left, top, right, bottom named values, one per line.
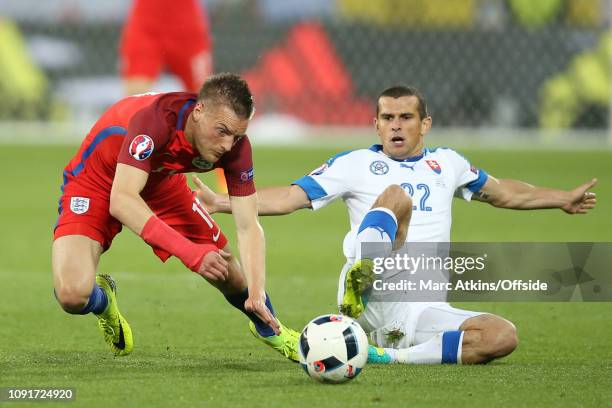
left=117, top=103, right=172, bottom=173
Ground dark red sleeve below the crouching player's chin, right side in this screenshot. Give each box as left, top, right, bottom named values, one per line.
left=220, top=137, right=255, bottom=197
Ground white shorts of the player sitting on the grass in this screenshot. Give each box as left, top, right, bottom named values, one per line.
left=338, top=263, right=484, bottom=348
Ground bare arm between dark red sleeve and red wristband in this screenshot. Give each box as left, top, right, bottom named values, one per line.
left=109, top=163, right=153, bottom=235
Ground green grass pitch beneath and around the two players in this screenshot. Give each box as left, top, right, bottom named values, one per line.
left=0, top=146, right=612, bottom=407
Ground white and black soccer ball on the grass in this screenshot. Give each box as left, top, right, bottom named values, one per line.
left=299, top=315, right=368, bottom=383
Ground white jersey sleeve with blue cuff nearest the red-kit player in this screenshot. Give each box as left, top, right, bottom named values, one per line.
left=291, top=153, right=350, bottom=210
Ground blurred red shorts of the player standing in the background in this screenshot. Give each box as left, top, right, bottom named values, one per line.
left=120, top=22, right=212, bottom=93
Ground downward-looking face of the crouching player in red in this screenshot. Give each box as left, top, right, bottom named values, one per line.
left=188, top=102, right=249, bottom=163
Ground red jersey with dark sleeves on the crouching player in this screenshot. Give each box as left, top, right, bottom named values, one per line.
left=62, top=92, right=255, bottom=201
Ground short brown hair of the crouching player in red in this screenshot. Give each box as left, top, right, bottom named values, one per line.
left=198, top=72, right=253, bottom=119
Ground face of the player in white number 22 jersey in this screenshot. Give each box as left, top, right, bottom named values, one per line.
left=374, top=95, right=431, bottom=160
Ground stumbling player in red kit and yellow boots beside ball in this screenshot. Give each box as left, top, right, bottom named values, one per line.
left=52, top=74, right=297, bottom=360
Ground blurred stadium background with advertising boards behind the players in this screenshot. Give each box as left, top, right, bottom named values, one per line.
left=0, top=0, right=612, bottom=148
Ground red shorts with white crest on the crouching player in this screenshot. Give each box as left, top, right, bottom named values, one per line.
left=53, top=176, right=227, bottom=262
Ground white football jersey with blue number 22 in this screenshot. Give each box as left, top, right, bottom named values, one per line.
left=293, top=145, right=488, bottom=260
